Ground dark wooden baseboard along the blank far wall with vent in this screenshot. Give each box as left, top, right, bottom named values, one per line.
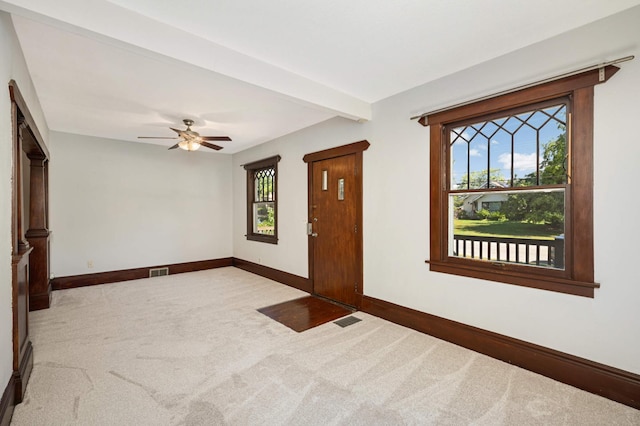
left=51, top=257, right=233, bottom=290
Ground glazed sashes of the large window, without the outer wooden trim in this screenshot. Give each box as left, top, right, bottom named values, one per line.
left=444, top=98, right=571, bottom=269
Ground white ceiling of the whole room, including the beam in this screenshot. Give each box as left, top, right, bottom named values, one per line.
left=0, top=0, right=640, bottom=153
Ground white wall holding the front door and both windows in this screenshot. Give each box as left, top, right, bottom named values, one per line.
left=233, top=7, right=640, bottom=373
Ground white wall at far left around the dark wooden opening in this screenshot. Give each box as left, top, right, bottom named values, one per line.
left=0, top=11, right=48, bottom=390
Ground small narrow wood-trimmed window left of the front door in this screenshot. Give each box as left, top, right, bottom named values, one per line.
left=244, top=156, right=280, bottom=244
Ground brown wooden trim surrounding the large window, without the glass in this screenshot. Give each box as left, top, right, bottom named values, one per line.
left=420, top=66, right=619, bottom=297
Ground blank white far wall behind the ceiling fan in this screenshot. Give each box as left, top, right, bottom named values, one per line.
left=49, top=132, right=232, bottom=276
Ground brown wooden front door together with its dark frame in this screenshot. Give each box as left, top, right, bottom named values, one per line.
left=305, top=141, right=369, bottom=307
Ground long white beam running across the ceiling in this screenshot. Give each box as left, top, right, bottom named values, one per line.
left=0, top=0, right=372, bottom=121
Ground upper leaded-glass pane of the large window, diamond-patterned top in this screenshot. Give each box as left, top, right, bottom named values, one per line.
left=449, top=104, right=567, bottom=190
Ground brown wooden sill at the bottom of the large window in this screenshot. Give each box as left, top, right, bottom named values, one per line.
left=425, top=260, right=600, bottom=298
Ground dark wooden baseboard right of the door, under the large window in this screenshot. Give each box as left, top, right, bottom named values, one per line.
left=362, top=296, right=640, bottom=409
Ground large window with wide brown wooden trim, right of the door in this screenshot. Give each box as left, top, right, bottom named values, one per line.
left=421, top=67, right=617, bottom=297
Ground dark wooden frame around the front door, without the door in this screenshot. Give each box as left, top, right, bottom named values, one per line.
left=302, top=140, right=370, bottom=309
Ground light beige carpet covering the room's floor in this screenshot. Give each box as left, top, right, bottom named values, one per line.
left=12, top=267, right=640, bottom=426
